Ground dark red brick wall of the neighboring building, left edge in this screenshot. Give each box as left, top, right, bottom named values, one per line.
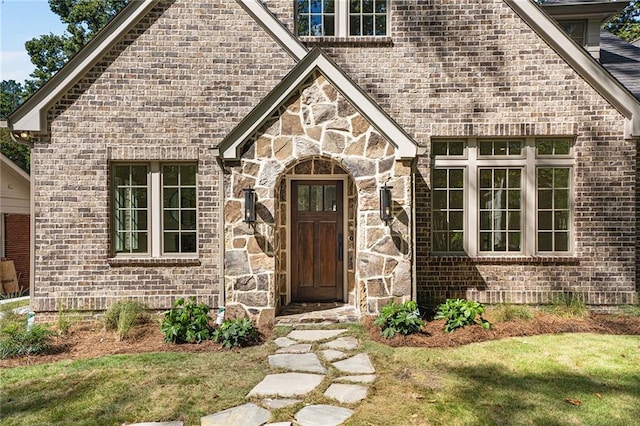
left=4, top=214, right=30, bottom=290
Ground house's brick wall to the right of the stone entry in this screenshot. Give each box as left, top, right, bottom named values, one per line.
left=268, top=0, right=637, bottom=304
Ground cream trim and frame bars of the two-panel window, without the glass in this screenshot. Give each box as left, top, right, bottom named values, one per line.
left=110, top=161, right=199, bottom=259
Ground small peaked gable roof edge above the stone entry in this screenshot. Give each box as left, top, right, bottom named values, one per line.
left=217, top=47, right=417, bottom=159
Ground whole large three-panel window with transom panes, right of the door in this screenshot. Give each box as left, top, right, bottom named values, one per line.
left=431, top=137, right=574, bottom=256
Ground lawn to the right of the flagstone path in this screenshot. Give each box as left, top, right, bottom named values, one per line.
left=356, top=334, right=640, bottom=425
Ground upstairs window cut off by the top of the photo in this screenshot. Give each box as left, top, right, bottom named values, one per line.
left=295, top=0, right=389, bottom=37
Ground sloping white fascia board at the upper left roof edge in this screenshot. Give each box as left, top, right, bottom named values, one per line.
left=9, top=0, right=159, bottom=133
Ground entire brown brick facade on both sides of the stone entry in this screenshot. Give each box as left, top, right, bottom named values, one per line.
left=32, top=0, right=638, bottom=318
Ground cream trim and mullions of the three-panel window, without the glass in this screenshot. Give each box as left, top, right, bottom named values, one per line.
left=432, top=137, right=575, bottom=257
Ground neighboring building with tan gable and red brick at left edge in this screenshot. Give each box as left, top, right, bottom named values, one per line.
left=0, top=154, right=31, bottom=291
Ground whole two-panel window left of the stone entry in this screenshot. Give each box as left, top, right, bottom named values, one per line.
left=111, top=161, right=198, bottom=257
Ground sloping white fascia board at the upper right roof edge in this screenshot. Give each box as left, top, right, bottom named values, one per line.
left=504, top=0, right=640, bottom=139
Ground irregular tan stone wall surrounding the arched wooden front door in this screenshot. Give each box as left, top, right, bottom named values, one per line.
left=225, top=74, right=412, bottom=322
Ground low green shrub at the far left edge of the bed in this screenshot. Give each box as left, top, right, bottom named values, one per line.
left=0, top=318, right=55, bottom=359
